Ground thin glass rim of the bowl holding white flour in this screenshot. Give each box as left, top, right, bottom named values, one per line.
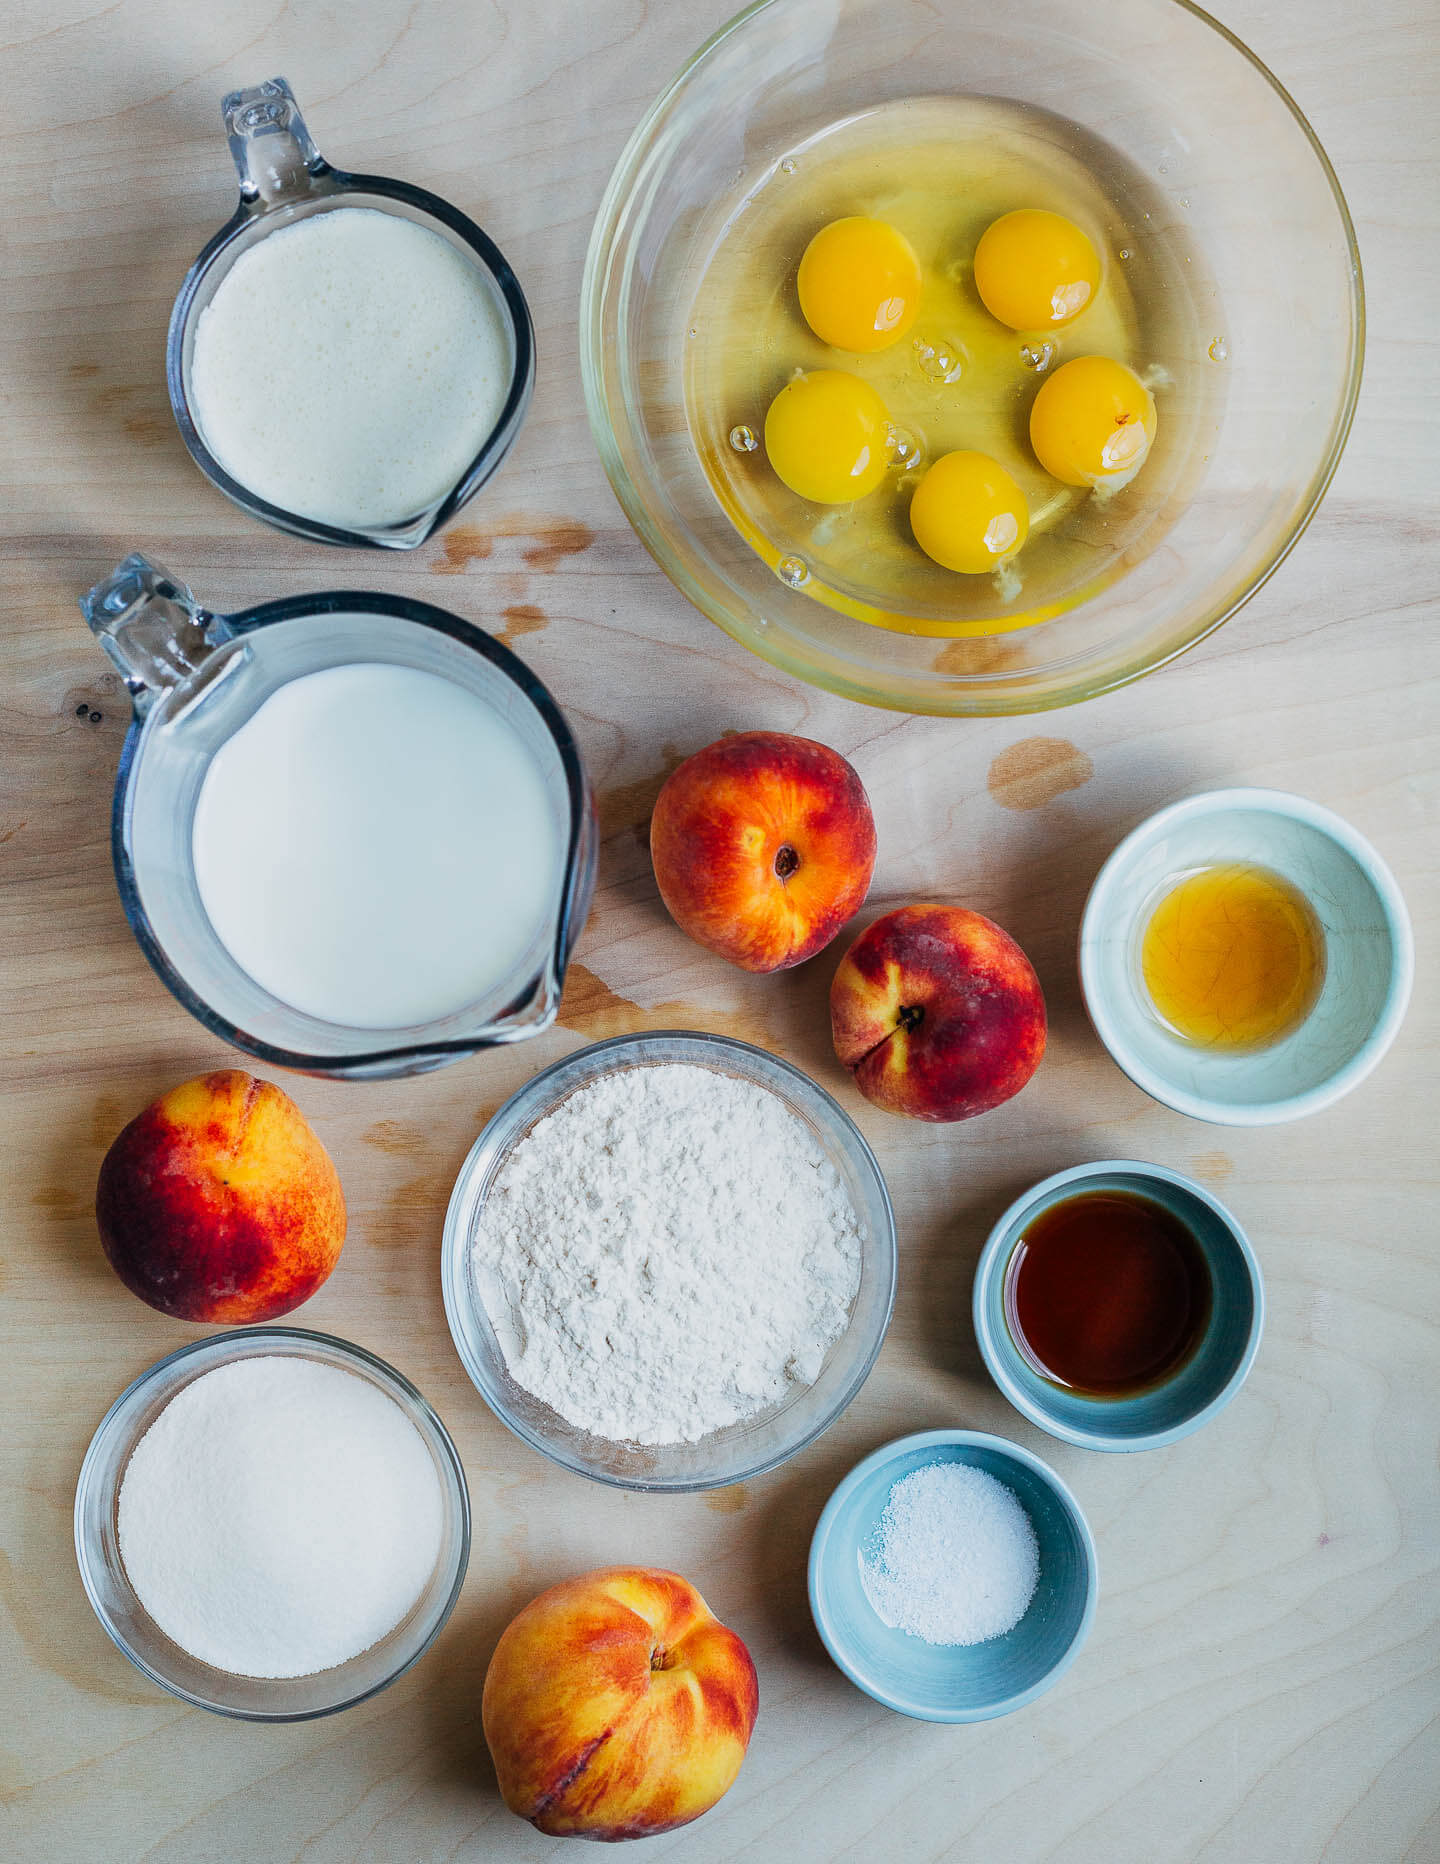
left=440, top=1029, right=900, bottom=1495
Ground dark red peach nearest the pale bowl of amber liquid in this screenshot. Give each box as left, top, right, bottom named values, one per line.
left=831, top=906, right=1045, bottom=1120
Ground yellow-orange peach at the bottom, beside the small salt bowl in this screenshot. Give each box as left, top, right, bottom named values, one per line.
left=481, top=1566, right=758, bottom=1838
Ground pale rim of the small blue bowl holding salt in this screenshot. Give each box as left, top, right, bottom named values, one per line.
left=807, top=1428, right=1099, bottom=1722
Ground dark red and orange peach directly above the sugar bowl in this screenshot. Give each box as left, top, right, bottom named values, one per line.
left=95, top=1068, right=345, bottom=1325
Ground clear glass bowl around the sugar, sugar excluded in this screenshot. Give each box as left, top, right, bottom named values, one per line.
left=75, top=1327, right=469, bottom=1722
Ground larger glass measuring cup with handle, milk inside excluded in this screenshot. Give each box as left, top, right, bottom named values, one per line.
left=80, top=554, right=598, bottom=1079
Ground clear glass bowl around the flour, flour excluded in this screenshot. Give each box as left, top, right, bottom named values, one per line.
left=442, top=1031, right=896, bottom=1489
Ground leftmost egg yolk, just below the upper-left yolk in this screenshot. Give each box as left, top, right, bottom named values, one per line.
left=766, top=369, right=890, bottom=505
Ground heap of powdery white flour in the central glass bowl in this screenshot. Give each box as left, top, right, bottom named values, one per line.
left=471, top=1062, right=861, bottom=1443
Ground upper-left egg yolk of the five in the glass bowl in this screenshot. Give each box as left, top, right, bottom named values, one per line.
left=795, top=214, right=920, bottom=350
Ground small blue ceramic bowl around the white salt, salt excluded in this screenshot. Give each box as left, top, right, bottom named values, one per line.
left=810, top=1430, right=1099, bottom=1722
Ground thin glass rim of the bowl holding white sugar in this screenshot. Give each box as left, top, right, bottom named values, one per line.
left=73, top=1325, right=471, bottom=1722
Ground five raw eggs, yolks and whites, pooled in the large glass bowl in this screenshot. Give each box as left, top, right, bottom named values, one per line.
left=684, top=97, right=1224, bottom=636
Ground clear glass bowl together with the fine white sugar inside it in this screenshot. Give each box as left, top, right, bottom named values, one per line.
left=75, top=1327, right=469, bottom=1722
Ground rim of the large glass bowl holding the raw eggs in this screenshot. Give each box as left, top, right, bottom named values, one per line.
left=577, top=0, right=1365, bottom=718
